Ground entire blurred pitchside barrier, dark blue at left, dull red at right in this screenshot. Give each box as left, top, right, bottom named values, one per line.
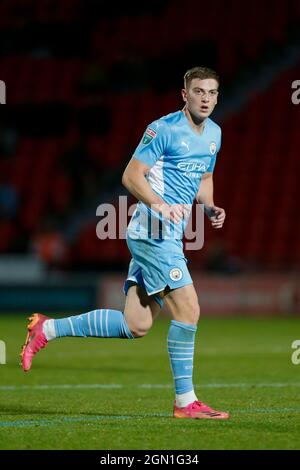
left=0, top=272, right=300, bottom=316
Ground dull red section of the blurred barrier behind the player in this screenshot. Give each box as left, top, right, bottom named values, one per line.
left=98, top=272, right=300, bottom=316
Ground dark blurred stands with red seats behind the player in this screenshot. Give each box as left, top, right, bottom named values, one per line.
left=0, top=0, right=300, bottom=276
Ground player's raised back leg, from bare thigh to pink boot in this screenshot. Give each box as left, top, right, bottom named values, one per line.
left=21, top=285, right=160, bottom=371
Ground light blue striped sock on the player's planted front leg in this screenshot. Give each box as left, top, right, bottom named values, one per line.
left=168, top=320, right=197, bottom=407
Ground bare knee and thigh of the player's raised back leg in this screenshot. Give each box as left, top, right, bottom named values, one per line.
left=124, top=284, right=161, bottom=336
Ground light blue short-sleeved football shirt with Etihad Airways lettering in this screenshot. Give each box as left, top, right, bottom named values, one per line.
left=128, top=111, right=221, bottom=238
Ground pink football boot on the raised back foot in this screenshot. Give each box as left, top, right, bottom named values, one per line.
left=20, top=313, right=50, bottom=372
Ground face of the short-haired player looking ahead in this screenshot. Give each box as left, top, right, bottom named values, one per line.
left=182, top=78, right=218, bottom=120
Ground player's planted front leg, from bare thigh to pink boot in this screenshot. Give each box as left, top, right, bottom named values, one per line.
left=164, top=284, right=229, bottom=419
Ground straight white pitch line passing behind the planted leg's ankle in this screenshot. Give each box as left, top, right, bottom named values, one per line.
left=0, top=382, right=300, bottom=391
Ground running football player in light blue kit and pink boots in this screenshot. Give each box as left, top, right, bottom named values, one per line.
left=21, top=67, right=229, bottom=419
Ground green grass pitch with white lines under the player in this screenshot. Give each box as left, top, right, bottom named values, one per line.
left=0, top=315, right=300, bottom=450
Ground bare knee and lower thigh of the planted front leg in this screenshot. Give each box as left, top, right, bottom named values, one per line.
left=164, top=284, right=200, bottom=325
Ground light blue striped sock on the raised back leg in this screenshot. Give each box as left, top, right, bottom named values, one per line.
left=43, top=309, right=134, bottom=341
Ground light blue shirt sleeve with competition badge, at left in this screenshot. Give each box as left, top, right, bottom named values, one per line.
left=133, top=120, right=171, bottom=167
